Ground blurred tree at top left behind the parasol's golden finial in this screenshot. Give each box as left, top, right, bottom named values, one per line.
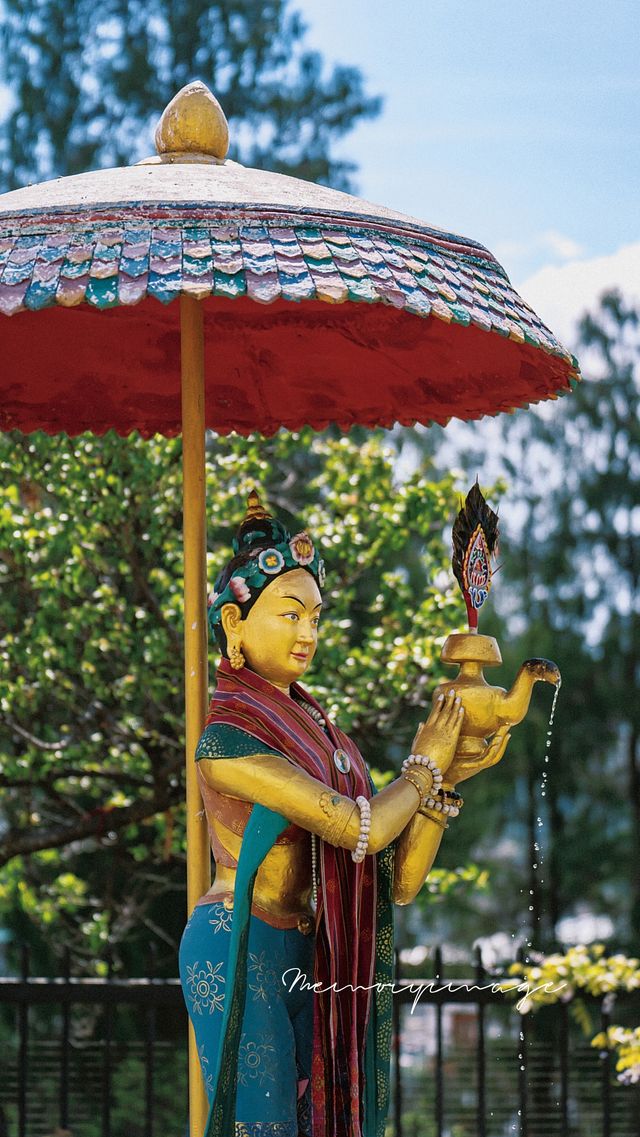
left=0, top=0, right=381, bottom=189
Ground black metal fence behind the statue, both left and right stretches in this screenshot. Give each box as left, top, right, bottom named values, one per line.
left=0, top=949, right=640, bottom=1137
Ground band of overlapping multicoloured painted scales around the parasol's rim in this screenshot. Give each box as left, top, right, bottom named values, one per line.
left=0, top=202, right=575, bottom=350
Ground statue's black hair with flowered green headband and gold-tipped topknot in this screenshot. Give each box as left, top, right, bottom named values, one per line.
left=209, top=490, right=325, bottom=631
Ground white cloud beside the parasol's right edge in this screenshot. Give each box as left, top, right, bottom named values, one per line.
left=517, top=241, right=640, bottom=348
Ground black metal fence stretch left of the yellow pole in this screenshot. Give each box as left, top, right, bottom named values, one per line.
left=0, top=952, right=188, bottom=1137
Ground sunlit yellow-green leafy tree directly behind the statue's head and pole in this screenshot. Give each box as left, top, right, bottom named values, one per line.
left=0, top=431, right=459, bottom=958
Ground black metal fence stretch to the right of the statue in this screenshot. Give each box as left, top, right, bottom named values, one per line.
left=392, top=948, right=640, bottom=1137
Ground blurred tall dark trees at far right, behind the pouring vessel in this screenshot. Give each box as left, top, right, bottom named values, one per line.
left=436, top=293, right=640, bottom=946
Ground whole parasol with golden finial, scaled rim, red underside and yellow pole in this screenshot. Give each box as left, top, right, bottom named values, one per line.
left=0, top=83, right=577, bottom=1131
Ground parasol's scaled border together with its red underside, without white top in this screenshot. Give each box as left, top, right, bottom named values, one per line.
left=0, top=201, right=577, bottom=434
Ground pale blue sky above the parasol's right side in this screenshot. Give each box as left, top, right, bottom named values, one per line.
left=292, top=0, right=640, bottom=347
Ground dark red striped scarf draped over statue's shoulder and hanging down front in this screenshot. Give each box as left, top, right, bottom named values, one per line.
left=207, top=659, right=377, bottom=1137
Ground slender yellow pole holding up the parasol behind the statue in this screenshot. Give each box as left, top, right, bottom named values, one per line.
left=180, top=296, right=210, bottom=1137
